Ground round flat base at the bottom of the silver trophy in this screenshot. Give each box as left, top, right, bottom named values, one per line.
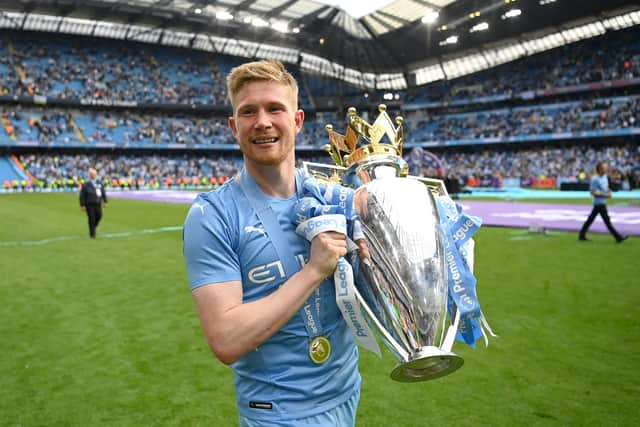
left=391, top=347, right=464, bottom=382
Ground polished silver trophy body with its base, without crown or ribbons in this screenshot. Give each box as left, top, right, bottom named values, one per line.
left=353, top=159, right=464, bottom=382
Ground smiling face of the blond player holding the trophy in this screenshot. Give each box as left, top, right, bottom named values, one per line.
left=229, top=81, right=304, bottom=166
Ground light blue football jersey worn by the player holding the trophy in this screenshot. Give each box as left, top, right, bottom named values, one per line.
left=183, top=167, right=361, bottom=420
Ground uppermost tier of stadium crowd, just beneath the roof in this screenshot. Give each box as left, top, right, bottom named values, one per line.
left=0, top=28, right=640, bottom=106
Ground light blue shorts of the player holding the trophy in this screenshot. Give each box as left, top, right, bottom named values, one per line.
left=240, top=390, right=360, bottom=427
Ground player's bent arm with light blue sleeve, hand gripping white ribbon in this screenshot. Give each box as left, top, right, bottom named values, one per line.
left=183, top=196, right=346, bottom=364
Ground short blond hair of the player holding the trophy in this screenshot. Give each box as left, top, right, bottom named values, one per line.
left=227, top=59, right=298, bottom=110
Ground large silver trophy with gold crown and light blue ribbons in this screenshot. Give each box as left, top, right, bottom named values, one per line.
left=305, top=105, right=491, bottom=382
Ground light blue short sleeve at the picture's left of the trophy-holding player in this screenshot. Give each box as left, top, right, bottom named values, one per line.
left=182, top=193, right=242, bottom=290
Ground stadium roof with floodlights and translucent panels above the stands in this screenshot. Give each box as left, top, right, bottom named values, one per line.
left=0, top=0, right=638, bottom=76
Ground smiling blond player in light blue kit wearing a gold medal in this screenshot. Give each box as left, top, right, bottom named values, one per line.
left=183, top=61, right=360, bottom=426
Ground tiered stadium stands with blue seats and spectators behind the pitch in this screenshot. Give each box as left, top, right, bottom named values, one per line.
left=0, top=27, right=640, bottom=195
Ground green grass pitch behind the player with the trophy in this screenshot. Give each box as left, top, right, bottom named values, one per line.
left=0, top=194, right=640, bottom=427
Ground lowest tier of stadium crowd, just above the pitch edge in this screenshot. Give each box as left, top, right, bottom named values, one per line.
left=5, top=143, right=640, bottom=189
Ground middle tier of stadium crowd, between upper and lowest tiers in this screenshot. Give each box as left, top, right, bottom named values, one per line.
left=0, top=95, right=640, bottom=147
